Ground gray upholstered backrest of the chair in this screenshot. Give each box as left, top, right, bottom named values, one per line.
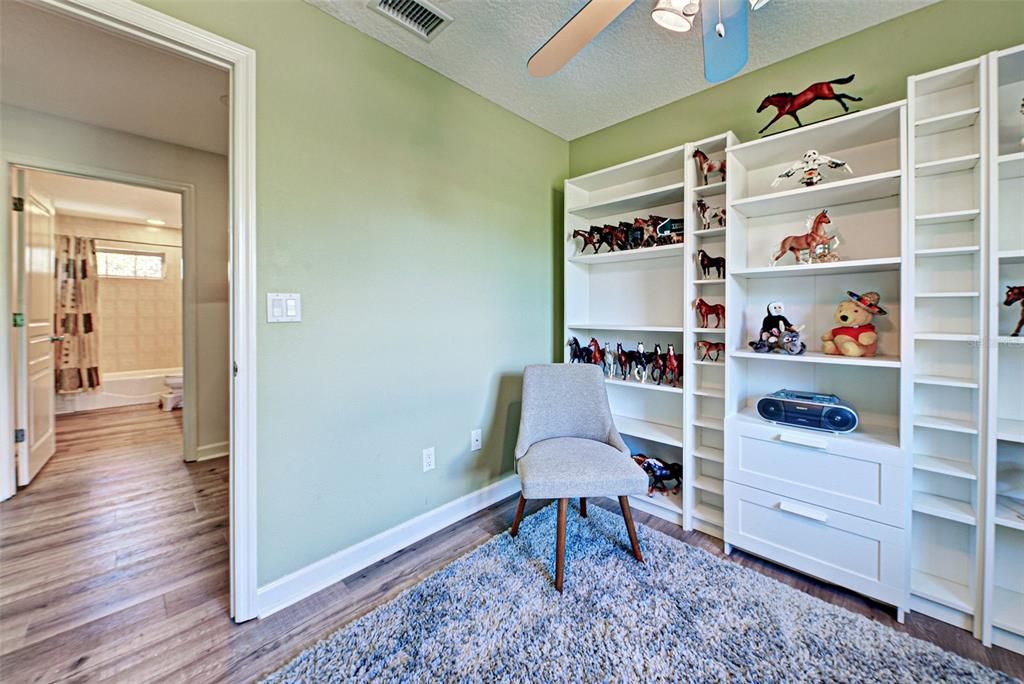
left=515, top=364, right=621, bottom=459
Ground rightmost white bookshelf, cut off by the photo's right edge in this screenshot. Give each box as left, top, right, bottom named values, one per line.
left=980, top=46, right=1024, bottom=653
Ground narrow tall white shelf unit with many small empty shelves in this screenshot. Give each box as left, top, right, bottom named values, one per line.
left=907, top=58, right=987, bottom=637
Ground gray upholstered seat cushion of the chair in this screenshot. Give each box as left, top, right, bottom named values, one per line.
left=519, top=437, right=647, bottom=499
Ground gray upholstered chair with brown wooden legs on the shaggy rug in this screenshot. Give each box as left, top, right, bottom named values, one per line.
left=509, top=364, right=647, bottom=592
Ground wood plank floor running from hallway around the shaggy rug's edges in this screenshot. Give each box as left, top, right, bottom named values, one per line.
left=0, top=408, right=1024, bottom=684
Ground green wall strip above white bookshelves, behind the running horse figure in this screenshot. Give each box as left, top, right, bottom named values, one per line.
left=569, top=0, right=1024, bottom=176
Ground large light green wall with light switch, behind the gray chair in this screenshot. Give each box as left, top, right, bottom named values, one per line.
left=136, top=0, right=568, bottom=585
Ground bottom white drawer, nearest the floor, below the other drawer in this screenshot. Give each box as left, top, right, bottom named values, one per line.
left=725, top=482, right=906, bottom=605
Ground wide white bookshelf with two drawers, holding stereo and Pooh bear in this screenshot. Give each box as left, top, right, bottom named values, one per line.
left=724, top=102, right=913, bottom=610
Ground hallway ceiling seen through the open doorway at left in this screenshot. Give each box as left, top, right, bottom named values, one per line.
left=0, top=0, right=228, bottom=155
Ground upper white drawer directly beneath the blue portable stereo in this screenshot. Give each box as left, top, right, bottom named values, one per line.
left=725, top=420, right=906, bottom=527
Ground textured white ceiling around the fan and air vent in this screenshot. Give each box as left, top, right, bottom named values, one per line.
left=306, top=0, right=936, bottom=140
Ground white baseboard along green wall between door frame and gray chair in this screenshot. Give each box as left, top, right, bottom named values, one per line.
left=256, top=475, right=519, bottom=617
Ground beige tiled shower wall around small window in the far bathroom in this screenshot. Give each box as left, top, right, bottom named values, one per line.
left=56, top=213, right=182, bottom=373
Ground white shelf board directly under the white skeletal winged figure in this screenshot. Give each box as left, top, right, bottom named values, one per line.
left=732, top=170, right=900, bottom=218
